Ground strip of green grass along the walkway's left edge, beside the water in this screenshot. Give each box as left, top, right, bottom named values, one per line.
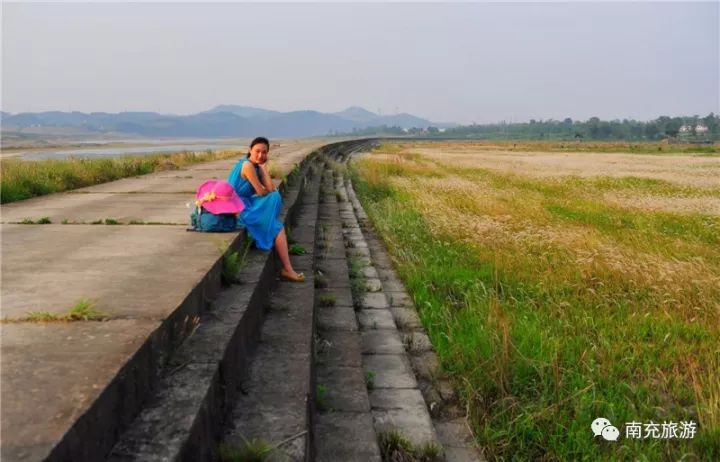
left=0, top=151, right=239, bottom=203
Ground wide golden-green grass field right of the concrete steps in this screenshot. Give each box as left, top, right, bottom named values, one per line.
left=355, top=143, right=720, bottom=460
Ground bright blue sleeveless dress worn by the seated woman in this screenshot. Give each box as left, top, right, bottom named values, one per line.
left=228, top=159, right=283, bottom=250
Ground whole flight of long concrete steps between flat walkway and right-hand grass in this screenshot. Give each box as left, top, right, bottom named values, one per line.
left=5, top=140, right=482, bottom=462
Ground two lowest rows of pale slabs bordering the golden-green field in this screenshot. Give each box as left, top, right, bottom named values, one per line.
left=336, top=167, right=485, bottom=462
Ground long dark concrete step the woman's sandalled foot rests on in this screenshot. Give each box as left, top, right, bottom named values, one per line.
left=214, top=143, right=379, bottom=461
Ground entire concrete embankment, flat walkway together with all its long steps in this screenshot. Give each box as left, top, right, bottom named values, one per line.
left=2, top=140, right=482, bottom=462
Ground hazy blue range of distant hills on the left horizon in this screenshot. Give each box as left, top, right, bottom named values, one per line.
left=2, top=105, right=447, bottom=138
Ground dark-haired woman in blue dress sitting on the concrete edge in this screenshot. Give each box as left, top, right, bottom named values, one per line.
left=228, top=137, right=305, bottom=282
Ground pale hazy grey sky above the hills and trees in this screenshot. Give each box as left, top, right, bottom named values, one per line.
left=2, top=1, right=720, bottom=123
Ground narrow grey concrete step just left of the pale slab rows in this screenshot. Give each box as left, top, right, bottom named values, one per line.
left=314, top=164, right=381, bottom=462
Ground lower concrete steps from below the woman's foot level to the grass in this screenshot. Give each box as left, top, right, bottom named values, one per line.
left=315, top=151, right=482, bottom=462
